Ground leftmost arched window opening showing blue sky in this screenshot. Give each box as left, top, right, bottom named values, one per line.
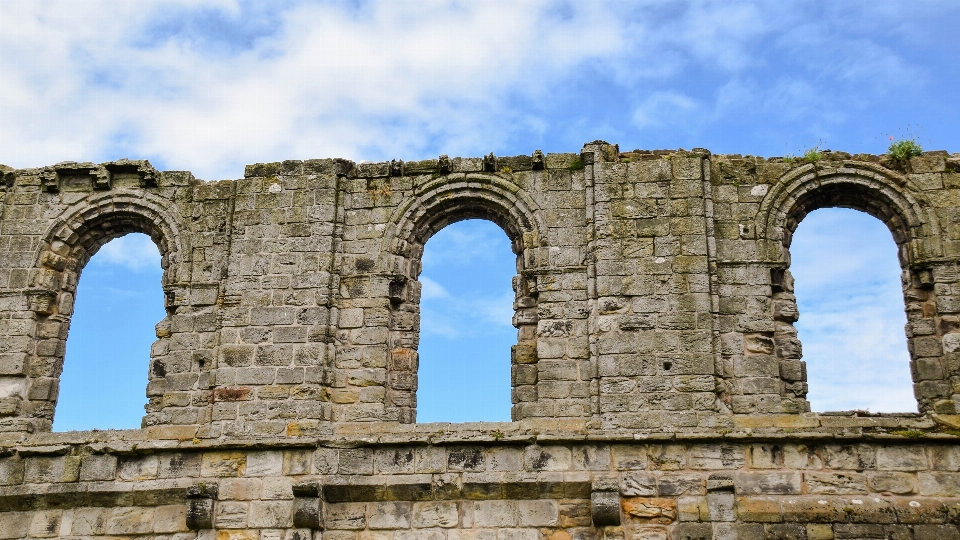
left=53, top=233, right=165, bottom=431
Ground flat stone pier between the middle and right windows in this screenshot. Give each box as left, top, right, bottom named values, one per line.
left=594, top=147, right=718, bottom=429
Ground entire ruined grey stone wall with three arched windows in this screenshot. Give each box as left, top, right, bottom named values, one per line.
left=0, top=141, right=960, bottom=540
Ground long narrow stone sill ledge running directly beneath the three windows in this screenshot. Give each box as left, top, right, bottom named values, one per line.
left=0, top=412, right=960, bottom=456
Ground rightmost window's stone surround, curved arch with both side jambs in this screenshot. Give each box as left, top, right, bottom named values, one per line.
left=756, top=162, right=949, bottom=411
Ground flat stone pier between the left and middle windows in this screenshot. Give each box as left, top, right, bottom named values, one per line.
left=210, top=160, right=337, bottom=436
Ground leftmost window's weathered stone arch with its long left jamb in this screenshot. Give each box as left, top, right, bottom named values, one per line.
left=26, top=193, right=189, bottom=431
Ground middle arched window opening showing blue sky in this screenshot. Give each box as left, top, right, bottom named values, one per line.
left=417, top=219, right=517, bottom=422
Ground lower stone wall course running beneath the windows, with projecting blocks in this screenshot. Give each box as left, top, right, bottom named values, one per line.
left=0, top=424, right=960, bottom=540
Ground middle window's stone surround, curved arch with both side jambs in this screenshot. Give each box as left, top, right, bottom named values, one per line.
left=384, top=174, right=546, bottom=423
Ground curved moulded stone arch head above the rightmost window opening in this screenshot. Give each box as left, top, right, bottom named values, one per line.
left=756, top=162, right=939, bottom=267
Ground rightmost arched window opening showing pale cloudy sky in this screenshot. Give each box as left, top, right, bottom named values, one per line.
left=790, top=208, right=917, bottom=412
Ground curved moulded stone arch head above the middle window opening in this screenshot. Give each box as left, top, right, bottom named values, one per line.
left=384, top=174, right=546, bottom=270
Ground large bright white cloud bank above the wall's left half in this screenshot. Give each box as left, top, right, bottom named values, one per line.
left=0, top=2, right=622, bottom=177
